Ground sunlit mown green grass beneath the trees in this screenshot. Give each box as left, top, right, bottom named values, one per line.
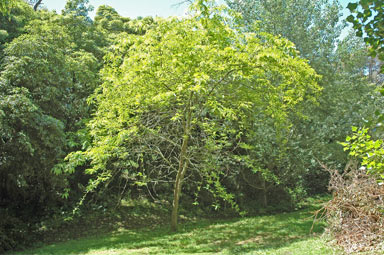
left=11, top=199, right=339, bottom=255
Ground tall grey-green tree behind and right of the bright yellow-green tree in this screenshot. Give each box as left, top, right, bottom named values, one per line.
left=227, top=0, right=378, bottom=195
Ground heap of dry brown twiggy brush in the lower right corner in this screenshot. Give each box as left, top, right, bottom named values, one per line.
left=318, top=163, right=384, bottom=254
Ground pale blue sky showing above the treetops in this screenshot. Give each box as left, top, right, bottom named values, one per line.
left=43, top=0, right=356, bottom=18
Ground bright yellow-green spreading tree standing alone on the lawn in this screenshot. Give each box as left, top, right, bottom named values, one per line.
left=64, top=1, right=320, bottom=230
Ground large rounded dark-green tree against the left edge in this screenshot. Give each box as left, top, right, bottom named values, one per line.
left=0, top=10, right=98, bottom=251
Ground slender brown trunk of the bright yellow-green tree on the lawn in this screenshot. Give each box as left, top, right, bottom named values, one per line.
left=171, top=92, right=193, bottom=231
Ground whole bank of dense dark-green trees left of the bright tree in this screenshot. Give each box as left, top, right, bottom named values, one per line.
left=0, top=1, right=154, bottom=251
